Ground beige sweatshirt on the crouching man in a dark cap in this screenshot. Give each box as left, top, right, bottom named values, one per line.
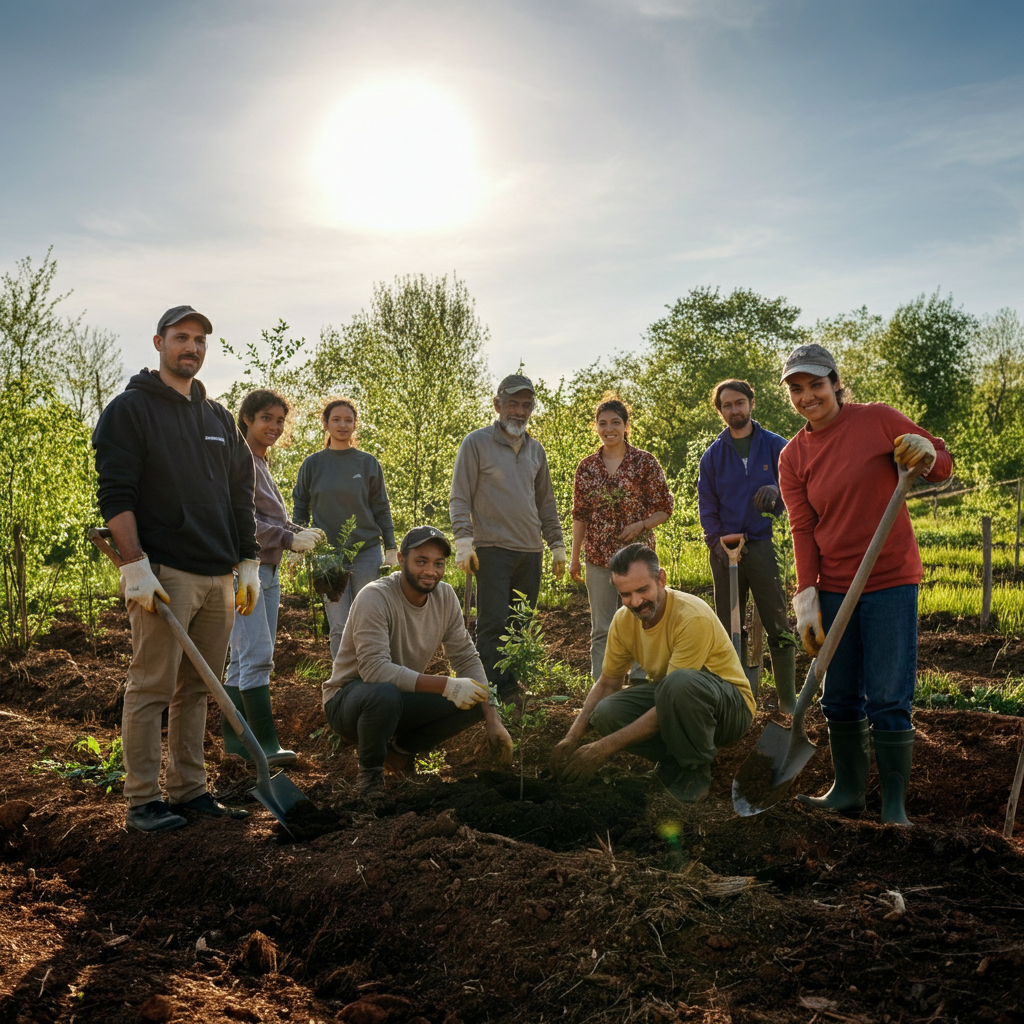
left=324, top=572, right=486, bottom=705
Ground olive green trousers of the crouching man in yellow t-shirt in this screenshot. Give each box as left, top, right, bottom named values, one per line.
left=590, top=669, right=754, bottom=767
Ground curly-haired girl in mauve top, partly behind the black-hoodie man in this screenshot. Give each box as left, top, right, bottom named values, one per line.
left=220, top=388, right=324, bottom=765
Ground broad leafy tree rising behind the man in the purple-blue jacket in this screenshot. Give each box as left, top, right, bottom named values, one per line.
left=617, top=287, right=807, bottom=472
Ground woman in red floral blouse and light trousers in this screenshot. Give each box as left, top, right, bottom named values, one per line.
left=569, top=391, right=673, bottom=680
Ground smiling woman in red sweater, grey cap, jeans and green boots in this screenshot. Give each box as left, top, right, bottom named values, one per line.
left=778, top=345, right=952, bottom=824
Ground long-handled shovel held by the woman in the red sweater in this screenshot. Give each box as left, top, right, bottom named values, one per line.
left=732, top=460, right=928, bottom=818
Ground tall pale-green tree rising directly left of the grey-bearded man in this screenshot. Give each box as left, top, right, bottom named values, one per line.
left=304, top=274, right=490, bottom=534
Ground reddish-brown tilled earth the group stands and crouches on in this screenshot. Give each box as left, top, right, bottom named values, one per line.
left=0, top=599, right=1024, bottom=1024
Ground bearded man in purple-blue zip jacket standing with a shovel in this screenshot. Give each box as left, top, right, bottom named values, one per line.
left=697, top=380, right=797, bottom=714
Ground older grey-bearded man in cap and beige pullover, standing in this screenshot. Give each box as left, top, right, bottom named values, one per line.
left=450, top=374, right=566, bottom=702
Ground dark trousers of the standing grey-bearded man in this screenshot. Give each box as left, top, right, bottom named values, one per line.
left=476, top=548, right=544, bottom=697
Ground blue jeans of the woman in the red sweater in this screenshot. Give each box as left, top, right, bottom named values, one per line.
left=818, top=584, right=918, bottom=731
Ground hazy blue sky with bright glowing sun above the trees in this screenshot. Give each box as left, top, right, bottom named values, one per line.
left=0, top=0, right=1024, bottom=393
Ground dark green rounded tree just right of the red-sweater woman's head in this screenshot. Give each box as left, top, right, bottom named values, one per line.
left=879, top=291, right=978, bottom=439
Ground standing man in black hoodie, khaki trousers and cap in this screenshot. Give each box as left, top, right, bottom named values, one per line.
left=92, top=306, right=259, bottom=831
